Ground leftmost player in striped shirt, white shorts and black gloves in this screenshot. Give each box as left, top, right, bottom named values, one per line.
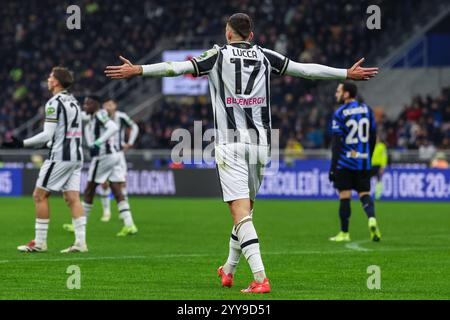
left=3, top=67, right=88, bottom=253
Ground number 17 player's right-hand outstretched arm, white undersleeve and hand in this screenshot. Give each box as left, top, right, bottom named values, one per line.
left=285, top=58, right=378, bottom=81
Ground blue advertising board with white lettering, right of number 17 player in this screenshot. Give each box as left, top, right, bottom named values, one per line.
left=259, top=160, right=450, bottom=201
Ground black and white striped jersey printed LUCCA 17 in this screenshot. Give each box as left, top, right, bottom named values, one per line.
left=191, top=42, right=289, bottom=146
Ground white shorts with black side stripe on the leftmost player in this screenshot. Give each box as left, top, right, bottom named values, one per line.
left=36, top=160, right=83, bottom=192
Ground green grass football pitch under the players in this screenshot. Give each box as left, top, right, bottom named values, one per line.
left=0, top=196, right=450, bottom=300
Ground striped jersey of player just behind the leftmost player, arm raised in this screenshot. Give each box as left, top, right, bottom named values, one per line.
left=84, top=109, right=118, bottom=157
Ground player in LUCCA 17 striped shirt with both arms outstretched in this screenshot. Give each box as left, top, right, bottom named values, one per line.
left=105, top=13, right=378, bottom=293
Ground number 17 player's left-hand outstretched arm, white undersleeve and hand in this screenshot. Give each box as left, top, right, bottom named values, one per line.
left=105, top=56, right=195, bottom=79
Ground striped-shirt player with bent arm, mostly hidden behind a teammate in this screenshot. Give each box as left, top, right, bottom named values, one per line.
left=99, top=98, right=139, bottom=222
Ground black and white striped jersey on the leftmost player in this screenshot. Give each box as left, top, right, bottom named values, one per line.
left=45, top=91, right=83, bottom=161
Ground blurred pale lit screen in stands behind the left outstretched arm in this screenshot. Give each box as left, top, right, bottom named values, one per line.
left=162, top=50, right=209, bottom=96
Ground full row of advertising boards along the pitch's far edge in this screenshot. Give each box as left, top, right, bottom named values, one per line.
left=8, top=160, right=450, bottom=201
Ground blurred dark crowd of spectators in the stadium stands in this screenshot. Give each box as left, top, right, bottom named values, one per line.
left=0, top=0, right=450, bottom=156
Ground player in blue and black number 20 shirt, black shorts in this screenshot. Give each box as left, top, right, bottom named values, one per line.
left=330, top=82, right=381, bottom=242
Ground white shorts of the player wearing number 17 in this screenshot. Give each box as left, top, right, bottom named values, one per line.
left=216, top=143, right=270, bottom=202
